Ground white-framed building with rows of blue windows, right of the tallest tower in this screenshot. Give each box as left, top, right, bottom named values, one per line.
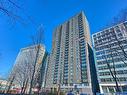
left=92, top=22, right=127, bottom=93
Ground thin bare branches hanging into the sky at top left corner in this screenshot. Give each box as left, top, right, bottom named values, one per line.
left=0, top=0, right=36, bottom=26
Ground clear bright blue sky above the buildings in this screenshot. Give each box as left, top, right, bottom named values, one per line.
left=0, top=0, right=127, bottom=77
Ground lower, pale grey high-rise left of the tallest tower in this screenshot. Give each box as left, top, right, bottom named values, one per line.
left=10, top=45, right=47, bottom=93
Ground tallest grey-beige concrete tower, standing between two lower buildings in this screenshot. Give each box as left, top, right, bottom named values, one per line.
left=46, top=12, right=98, bottom=95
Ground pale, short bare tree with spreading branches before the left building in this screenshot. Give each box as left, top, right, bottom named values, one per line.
left=6, top=47, right=34, bottom=95
